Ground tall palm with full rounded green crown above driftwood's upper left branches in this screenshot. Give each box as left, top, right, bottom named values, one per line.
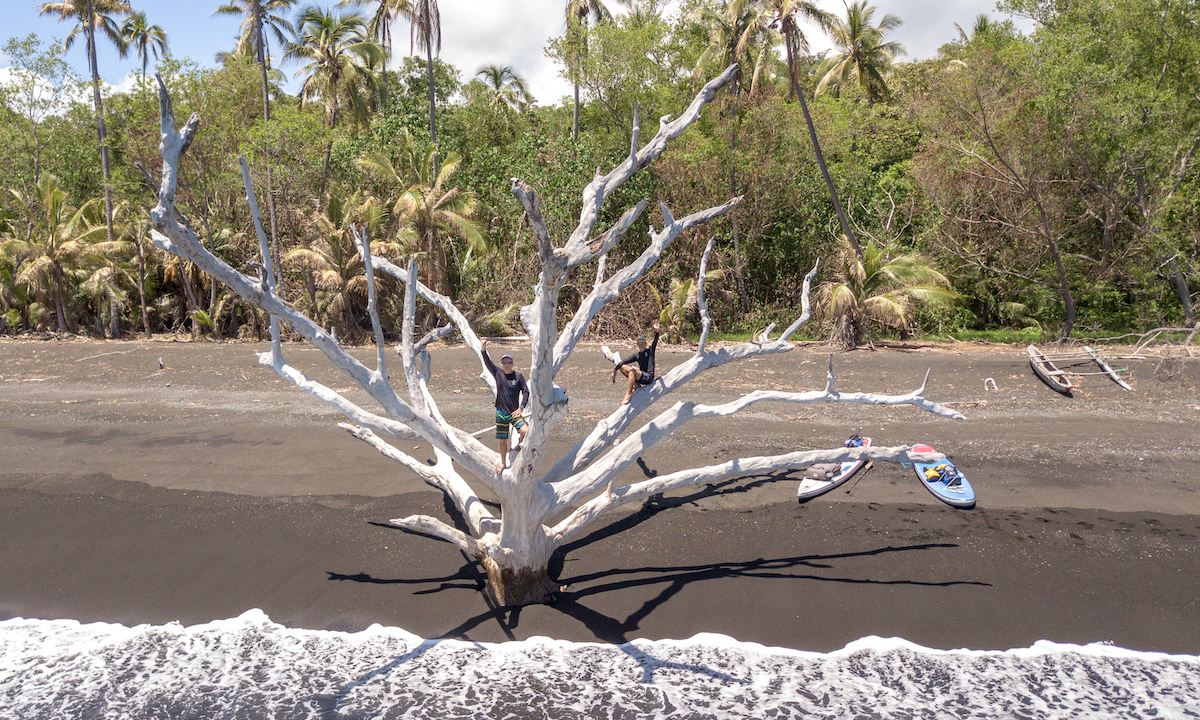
left=284, top=5, right=383, bottom=202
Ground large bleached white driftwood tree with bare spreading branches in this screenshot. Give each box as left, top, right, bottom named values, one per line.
left=151, top=66, right=961, bottom=605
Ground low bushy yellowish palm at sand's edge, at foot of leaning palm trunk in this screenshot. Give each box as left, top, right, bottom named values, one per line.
left=817, top=236, right=958, bottom=350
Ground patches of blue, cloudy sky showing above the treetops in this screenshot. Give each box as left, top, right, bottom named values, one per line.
left=0, top=0, right=1028, bottom=104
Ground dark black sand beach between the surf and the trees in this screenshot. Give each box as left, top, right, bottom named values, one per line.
left=0, top=340, right=1200, bottom=654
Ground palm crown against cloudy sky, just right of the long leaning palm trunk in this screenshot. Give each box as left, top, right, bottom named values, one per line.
left=816, top=0, right=905, bottom=102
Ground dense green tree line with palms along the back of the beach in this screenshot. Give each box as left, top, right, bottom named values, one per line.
left=0, top=0, right=1200, bottom=344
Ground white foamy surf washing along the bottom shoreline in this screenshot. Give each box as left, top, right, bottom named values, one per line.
left=0, top=610, right=1200, bottom=720
